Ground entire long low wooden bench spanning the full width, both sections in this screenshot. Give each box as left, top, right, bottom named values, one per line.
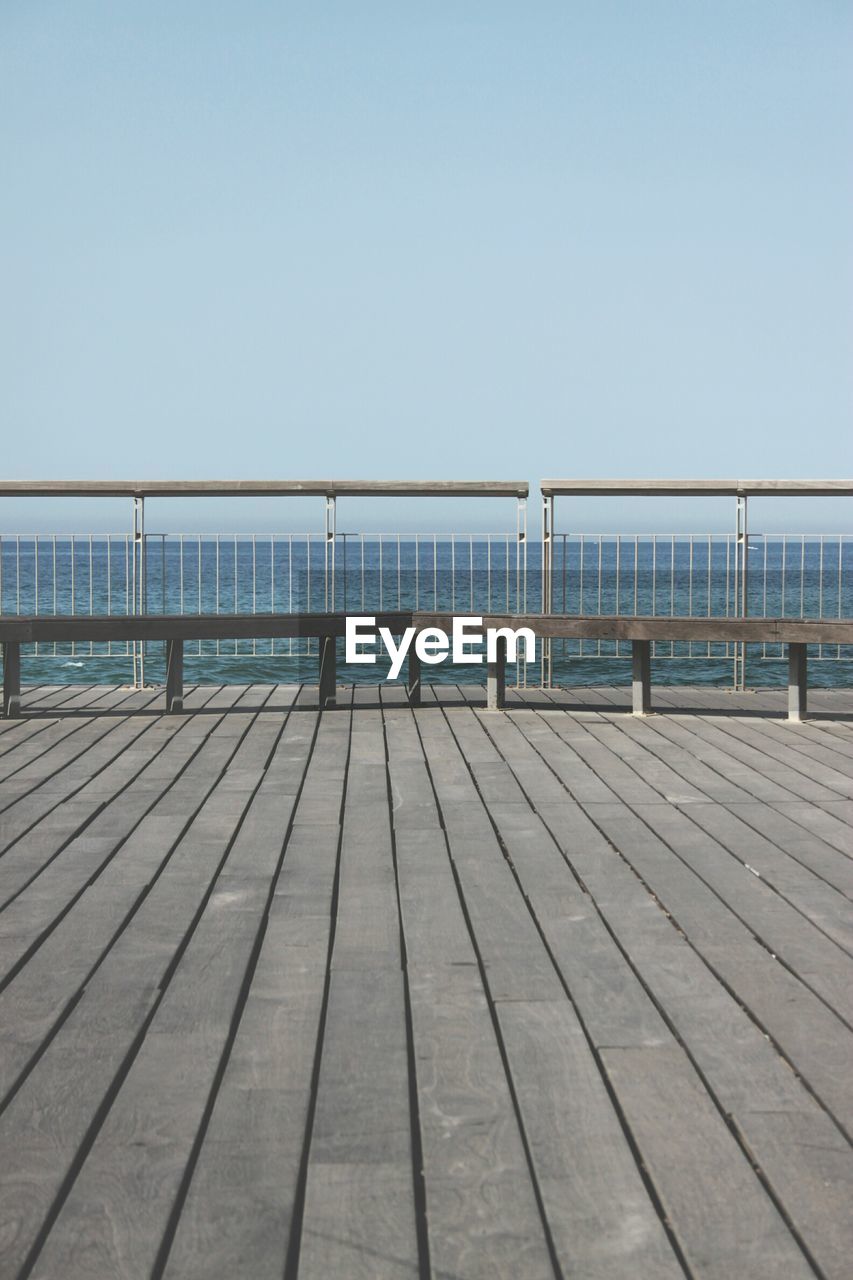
left=0, top=611, right=853, bottom=721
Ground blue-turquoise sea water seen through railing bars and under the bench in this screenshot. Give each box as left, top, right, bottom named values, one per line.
left=0, top=535, right=853, bottom=686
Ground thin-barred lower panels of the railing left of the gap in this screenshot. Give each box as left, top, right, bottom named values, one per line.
left=0, top=522, right=528, bottom=684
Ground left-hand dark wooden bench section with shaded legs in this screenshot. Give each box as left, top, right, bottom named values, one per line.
left=0, top=612, right=412, bottom=717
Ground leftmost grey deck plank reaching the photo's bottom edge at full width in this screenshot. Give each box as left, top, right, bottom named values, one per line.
left=24, top=701, right=315, bottom=1274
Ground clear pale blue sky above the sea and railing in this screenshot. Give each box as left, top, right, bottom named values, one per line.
left=0, top=0, right=853, bottom=531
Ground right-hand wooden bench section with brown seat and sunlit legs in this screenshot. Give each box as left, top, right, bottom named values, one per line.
left=412, top=613, right=853, bottom=721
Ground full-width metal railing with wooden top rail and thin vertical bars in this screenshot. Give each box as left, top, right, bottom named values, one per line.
left=0, top=480, right=853, bottom=685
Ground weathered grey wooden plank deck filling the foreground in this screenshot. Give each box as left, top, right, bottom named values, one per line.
left=0, top=686, right=853, bottom=1280
